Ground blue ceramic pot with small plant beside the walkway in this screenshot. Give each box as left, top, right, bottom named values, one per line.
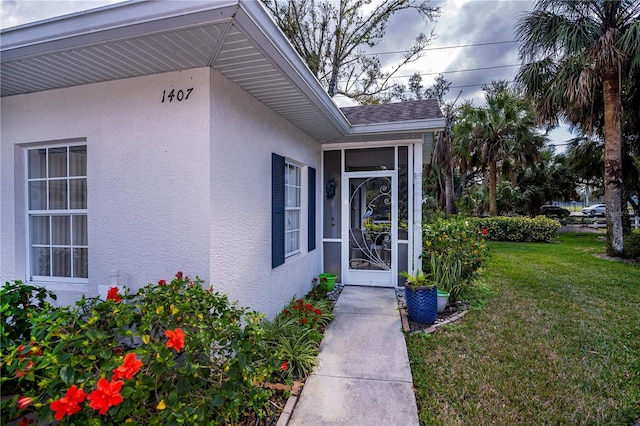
left=400, top=270, right=438, bottom=324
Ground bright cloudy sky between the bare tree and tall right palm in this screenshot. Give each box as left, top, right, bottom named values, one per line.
left=375, top=0, right=533, bottom=104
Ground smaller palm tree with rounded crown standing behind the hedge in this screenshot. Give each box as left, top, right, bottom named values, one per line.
left=453, top=82, right=543, bottom=216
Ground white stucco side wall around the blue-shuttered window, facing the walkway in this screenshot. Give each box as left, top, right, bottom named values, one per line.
left=210, top=71, right=322, bottom=317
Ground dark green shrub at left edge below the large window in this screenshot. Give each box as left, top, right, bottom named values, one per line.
left=0, top=281, right=56, bottom=348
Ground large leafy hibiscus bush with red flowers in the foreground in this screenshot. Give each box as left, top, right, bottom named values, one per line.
left=0, top=273, right=278, bottom=425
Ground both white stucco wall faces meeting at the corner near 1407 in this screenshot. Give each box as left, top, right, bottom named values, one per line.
left=0, top=68, right=321, bottom=317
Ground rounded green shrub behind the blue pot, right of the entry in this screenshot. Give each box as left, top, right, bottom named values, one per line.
left=422, top=218, right=488, bottom=280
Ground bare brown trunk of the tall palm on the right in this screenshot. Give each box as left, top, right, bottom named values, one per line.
left=603, top=68, right=624, bottom=256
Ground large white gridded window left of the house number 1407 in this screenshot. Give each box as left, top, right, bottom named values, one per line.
left=27, top=145, right=89, bottom=282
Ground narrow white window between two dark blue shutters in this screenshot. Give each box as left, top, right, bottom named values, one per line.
left=284, top=162, right=302, bottom=257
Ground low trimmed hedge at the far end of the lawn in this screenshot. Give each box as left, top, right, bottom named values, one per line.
left=470, top=216, right=560, bottom=242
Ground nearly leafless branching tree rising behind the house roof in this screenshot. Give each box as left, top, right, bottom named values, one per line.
left=263, top=0, right=439, bottom=103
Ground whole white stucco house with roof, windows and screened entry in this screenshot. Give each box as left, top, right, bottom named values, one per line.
left=0, top=0, right=444, bottom=316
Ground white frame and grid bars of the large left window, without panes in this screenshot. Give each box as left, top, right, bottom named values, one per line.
left=24, top=141, right=89, bottom=284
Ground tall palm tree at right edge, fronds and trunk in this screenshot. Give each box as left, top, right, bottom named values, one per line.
left=516, top=0, right=640, bottom=255
